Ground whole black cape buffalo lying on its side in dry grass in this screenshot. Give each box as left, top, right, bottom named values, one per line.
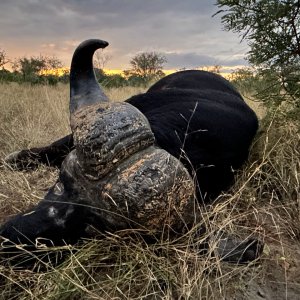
left=0, top=39, right=258, bottom=262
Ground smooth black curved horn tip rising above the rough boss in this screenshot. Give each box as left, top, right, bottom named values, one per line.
left=70, top=39, right=108, bottom=118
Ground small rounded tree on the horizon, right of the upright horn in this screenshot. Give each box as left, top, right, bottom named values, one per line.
left=126, top=51, right=167, bottom=80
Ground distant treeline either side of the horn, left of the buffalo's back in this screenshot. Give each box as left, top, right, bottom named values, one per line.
left=0, top=49, right=166, bottom=88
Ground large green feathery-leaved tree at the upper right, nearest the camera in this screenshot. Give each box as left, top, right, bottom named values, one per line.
left=216, top=0, right=300, bottom=106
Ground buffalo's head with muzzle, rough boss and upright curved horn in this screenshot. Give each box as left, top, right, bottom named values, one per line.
left=0, top=39, right=194, bottom=247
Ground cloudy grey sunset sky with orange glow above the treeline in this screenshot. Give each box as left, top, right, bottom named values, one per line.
left=0, top=0, right=248, bottom=69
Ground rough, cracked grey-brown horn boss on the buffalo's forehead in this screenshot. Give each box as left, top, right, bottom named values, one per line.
left=71, top=102, right=195, bottom=231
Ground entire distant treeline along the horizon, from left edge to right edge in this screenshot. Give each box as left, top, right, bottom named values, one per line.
left=0, top=49, right=300, bottom=113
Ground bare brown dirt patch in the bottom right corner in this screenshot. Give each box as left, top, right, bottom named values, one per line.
left=224, top=212, right=300, bottom=300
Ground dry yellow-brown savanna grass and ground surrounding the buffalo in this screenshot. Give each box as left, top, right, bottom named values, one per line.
left=0, top=84, right=300, bottom=300
